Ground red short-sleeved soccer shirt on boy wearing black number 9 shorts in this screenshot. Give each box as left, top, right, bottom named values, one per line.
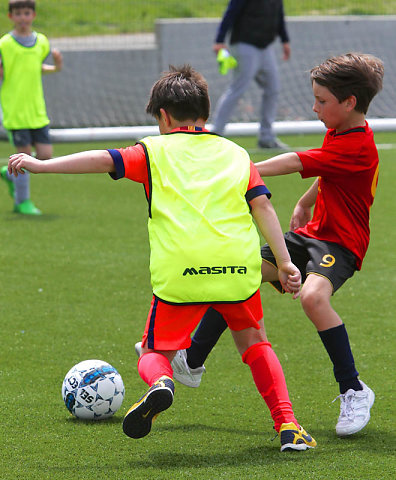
left=296, top=122, right=378, bottom=270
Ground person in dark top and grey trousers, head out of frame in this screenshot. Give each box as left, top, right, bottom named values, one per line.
left=213, top=0, right=290, bottom=149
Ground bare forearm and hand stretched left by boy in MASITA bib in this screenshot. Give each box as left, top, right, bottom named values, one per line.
left=8, top=150, right=115, bottom=176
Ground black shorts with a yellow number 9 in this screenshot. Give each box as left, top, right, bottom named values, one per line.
left=261, top=232, right=357, bottom=293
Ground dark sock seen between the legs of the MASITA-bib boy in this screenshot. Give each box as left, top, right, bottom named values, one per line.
left=187, top=307, right=227, bottom=368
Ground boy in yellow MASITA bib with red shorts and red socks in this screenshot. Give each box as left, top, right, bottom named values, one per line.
left=9, top=65, right=316, bottom=451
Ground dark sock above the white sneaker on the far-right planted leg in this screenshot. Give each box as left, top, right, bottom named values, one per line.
left=318, top=324, right=363, bottom=393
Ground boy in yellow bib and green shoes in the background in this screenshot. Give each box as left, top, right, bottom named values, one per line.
left=0, top=0, right=63, bottom=215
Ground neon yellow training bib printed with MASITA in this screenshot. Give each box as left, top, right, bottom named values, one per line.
left=140, top=132, right=261, bottom=304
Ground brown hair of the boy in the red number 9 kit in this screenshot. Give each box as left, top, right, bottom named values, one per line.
left=311, top=53, right=384, bottom=113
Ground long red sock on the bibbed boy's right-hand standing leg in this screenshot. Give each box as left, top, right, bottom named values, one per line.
left=242, top=342, right=299, bottom=432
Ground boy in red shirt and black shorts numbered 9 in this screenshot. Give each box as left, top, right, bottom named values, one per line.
left=166, top=53, right=384, bottom=436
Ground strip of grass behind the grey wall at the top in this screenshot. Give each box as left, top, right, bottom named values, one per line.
left=0, top=0, right=396, bottom=37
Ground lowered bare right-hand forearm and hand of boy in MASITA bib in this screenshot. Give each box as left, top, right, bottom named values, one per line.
left=250, top=195, right=301, bottom=298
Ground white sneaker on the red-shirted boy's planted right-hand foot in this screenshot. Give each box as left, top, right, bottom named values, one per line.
left=333, top=380, right=375, bottom=437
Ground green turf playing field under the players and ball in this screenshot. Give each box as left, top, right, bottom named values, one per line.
left=0, top=134, right=396, bottom=480
